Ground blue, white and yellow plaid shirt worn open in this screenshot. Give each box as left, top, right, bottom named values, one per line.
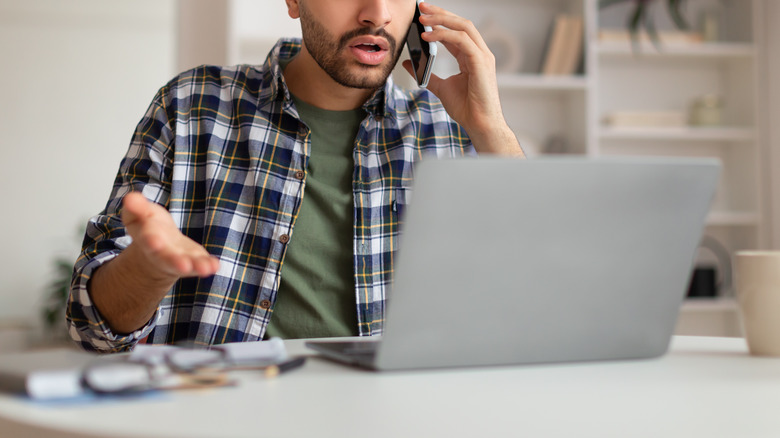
left=67, top=40, right=474, bottom=351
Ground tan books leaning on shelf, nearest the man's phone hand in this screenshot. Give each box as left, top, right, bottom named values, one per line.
left=542, top=14, right=583, bottom=75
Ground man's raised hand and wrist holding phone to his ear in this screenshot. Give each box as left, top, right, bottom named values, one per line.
left=404, top=2, right=523, bottom=156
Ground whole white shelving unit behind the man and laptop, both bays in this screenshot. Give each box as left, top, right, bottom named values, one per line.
left=221, top=0, right=769, bottom=336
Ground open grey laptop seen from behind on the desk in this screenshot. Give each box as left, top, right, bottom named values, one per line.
left=306, top=157, right=720, bottom=370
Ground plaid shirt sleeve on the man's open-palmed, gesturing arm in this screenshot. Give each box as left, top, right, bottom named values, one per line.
left=66, top=87, right=175, bottom=352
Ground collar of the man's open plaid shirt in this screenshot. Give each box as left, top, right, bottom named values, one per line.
left=260, top=38, right=396, bottom=118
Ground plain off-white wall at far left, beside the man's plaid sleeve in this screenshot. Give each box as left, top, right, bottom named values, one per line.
left=0, top=0, right=176, bottom=324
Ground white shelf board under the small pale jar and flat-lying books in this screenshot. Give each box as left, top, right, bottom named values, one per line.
left=599, top=126, right=755, bottom=142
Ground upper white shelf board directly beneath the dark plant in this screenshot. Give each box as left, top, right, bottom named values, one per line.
left=595, top=42, right=756, bottom=58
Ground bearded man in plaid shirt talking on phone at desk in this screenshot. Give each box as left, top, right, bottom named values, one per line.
left=68, top=0, right=522, bottom=351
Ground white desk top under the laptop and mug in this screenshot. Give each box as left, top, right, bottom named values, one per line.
left=0, top=337, right=780, bottom=438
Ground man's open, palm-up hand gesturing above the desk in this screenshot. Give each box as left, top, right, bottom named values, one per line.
left=122, top=192, right=219, bottom=281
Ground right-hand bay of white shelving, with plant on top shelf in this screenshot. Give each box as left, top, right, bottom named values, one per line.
left=586, top=0, right=766, bottom=336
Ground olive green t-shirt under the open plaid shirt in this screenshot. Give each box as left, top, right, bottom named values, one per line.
left=266, top=93, right=366, bottom=339
